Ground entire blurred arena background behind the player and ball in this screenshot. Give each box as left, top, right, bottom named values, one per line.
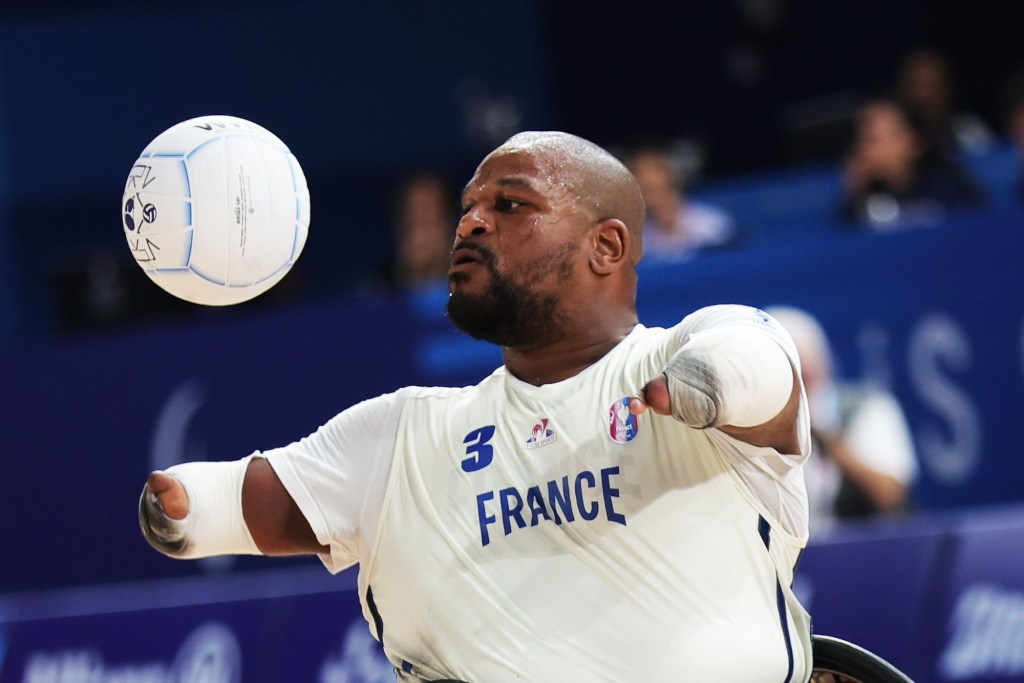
left=0, top=0, right=1024, bottom=681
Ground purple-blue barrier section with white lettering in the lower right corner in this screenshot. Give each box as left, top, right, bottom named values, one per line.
left=795, top=506, right=1024, bottom=683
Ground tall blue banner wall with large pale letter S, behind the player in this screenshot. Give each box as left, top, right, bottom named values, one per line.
left=0, top=204, right=1024, bottom=594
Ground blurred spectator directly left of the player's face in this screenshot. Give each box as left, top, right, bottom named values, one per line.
left=386, top=171, right=457, bottom=289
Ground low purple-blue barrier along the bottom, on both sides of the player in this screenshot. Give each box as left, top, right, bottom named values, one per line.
left=0, top=506, right=1024, bottom=683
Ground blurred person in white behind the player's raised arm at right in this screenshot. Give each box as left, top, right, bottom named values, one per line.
left=768, top=306, right=918, bottom=532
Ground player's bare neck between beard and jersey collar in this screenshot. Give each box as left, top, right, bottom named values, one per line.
left=503, top=311, right=637, bottom=386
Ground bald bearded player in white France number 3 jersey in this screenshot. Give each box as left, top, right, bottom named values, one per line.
left=139, top=132, right=811, bottom=683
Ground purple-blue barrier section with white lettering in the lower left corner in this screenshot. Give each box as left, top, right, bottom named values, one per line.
left=0, top=569, right=394, bottom=683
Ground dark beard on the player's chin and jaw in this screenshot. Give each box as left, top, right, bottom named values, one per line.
left=447, top=245, right=575, bottom=348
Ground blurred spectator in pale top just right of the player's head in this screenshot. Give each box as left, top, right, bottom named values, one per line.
left=626, top=148, right=739, bottom=262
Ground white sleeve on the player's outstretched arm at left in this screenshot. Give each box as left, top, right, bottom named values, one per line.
left=257, top=391, right=406, bottom=572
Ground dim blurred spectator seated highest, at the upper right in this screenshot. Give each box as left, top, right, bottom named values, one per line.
left=896, top=48, right=992, bottom=155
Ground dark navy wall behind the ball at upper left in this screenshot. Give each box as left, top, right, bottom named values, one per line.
left=0, top=0, right=550, bottom=345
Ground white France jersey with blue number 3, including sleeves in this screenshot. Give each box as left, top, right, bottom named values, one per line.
left=265, top=306, right=811, bottom=683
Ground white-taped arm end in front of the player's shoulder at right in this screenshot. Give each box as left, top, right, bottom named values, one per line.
left=665, top=326, right=793, bottom=429
